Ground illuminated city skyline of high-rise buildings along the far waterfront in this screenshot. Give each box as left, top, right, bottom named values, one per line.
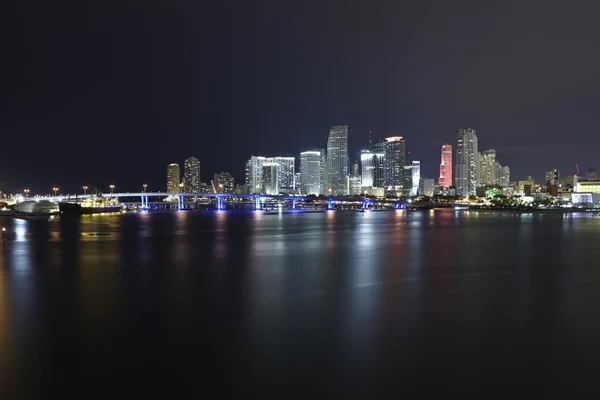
left=162, top=125, right=600, bottom=206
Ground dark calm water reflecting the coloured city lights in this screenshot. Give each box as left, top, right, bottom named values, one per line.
left=0, top=210, right=600, bottom=399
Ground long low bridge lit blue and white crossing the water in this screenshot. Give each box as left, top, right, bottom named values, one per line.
left=20, top=192, right=405, bottom=210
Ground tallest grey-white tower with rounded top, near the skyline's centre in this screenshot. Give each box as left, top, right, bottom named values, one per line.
left=327, top=125, right=348, bottom=196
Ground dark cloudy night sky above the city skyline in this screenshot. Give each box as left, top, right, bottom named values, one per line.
left=0, top=0, right=600, bottom=192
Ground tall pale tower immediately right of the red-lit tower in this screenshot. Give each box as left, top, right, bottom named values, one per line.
left=454, top=128, right=479, bottom=196
